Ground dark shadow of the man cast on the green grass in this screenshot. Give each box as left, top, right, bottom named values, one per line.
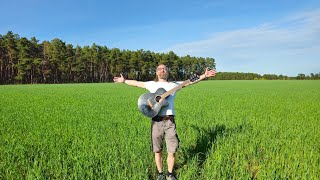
left=175, top=124, right=250, bottom=175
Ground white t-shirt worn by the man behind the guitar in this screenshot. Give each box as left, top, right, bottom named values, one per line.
left=144, top=81, right=182, bottom=116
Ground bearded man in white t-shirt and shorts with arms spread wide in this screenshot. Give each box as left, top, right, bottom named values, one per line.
left=113, top=64, right=216, bottom=180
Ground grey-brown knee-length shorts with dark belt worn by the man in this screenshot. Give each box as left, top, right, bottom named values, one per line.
left=151, top=116, right=179, bottom=153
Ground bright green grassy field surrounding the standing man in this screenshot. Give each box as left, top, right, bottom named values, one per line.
left=0, top=81, right=320, bottom=180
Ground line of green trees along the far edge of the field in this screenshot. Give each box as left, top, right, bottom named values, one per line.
left=0, top=31, right=320, bottom=84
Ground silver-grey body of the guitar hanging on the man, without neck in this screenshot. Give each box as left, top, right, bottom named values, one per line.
left=138, top=88, right=168, bottom=118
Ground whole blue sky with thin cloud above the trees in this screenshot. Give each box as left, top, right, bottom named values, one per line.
left=0, top=0, right=320, bottom=76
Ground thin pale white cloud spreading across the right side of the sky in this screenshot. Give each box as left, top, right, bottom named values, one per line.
left=168, top=9, right=320, bottom=76
